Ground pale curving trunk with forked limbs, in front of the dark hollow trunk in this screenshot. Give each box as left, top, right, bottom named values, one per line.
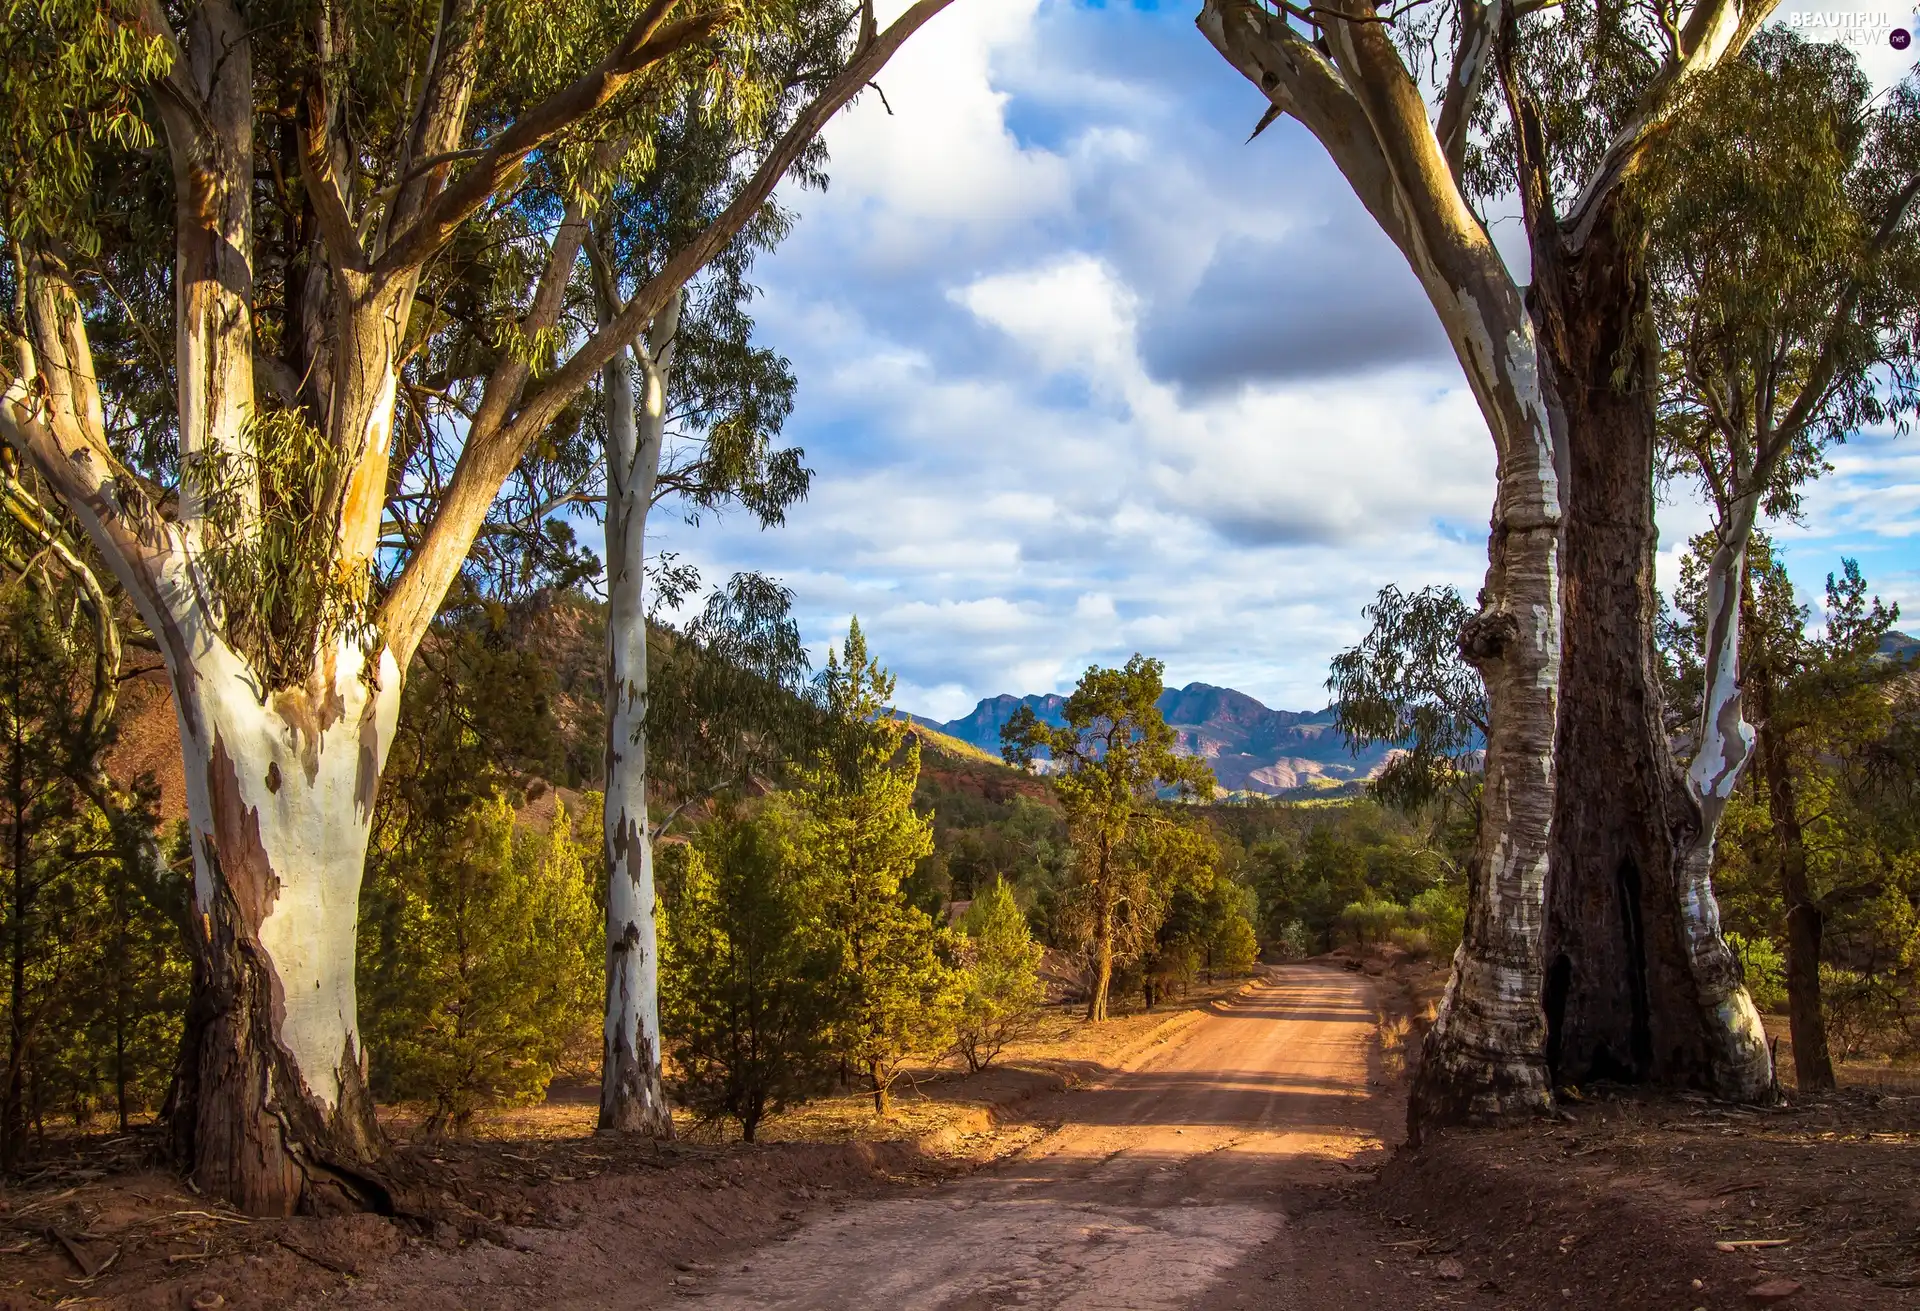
left=1198, top=0, right=1764, bottom=1132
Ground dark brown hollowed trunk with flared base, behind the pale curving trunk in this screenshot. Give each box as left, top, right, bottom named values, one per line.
left=1530, top=191, right=1770, bottom=1098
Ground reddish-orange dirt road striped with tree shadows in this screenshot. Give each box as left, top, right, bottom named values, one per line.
left=674, top=965, right=1413, bottom=1311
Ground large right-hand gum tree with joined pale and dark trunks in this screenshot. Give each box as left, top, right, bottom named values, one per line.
left=1198, top=0, right=1772, bottom=1129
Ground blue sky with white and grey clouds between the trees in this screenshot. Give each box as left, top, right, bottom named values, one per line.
left=649, top=0, right=1920, bottom=718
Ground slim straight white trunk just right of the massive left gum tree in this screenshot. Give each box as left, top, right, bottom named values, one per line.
left=599, top=294, right=680, bottom=1138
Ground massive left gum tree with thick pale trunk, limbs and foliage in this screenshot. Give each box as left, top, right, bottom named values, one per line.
left=0, top=0, right=947, bottom=1213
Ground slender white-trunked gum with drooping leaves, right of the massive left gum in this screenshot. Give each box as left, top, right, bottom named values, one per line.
left=588, top=82, right=810, bottom=1136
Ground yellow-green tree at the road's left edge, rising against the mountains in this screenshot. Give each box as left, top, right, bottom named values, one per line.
left=1000, top=655, right=1213, bottom=1021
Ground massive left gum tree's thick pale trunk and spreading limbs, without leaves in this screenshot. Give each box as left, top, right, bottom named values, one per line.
left=0, top=0, right=947, bottom=1215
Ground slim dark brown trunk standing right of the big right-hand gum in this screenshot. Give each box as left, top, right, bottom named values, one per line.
left=1741, top=598, right=1836, bottom=1092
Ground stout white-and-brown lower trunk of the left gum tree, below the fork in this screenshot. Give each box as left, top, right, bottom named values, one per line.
left=167, top=622, right=401, bottom=1213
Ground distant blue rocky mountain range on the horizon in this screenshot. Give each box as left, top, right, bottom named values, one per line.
left=908, top=683, right=1388, bottom=797
